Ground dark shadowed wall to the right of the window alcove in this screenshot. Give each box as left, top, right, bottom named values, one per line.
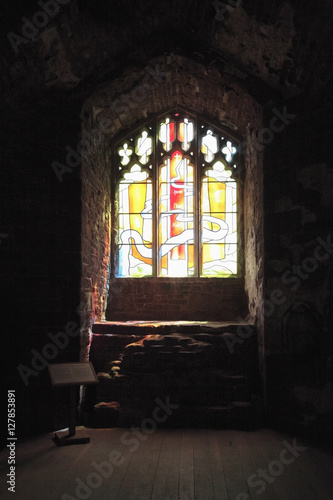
left=264, top=99, right=333, bottom=441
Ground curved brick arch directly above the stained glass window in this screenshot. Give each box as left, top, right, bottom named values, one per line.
left=84, top=55, right=261, bottom=138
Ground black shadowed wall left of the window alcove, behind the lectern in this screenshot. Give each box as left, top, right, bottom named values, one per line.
left=0, top=99, right=81, bottom=442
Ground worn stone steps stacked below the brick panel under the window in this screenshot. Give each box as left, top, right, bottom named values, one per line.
left=85, top=321, right=260, bottom=429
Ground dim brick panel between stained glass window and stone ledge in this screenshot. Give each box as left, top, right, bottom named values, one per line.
left=106, top=278, right=247, bottom=321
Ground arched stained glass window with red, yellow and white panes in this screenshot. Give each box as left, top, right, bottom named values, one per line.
left=115, top=111, right=239, bottom=278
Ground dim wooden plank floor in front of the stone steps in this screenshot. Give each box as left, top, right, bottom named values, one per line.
left=0, top=427, right=333, bottom=500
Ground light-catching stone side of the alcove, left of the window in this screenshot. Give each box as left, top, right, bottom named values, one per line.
left=80, top=121, right=111, bottom=361
